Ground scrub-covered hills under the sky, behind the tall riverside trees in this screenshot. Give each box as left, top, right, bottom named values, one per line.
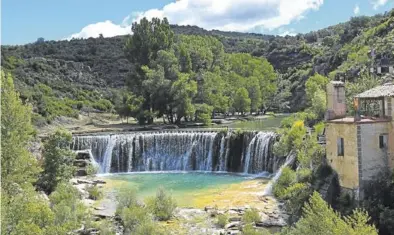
left=1, top=11, right=394, bottom=124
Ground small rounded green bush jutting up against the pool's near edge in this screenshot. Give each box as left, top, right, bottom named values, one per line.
left=147, top=187, right=176, bottom=220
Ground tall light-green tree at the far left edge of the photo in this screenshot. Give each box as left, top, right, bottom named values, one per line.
left=1, top=71, right=40, bottom=195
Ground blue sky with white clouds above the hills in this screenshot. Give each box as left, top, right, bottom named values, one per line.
left=1, top=0, right=394, bottom=45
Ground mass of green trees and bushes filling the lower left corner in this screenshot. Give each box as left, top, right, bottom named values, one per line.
left=1, top=71, right=88, bottom=235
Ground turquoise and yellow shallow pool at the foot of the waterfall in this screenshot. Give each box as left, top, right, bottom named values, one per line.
left=98, top=172, right=268, bottom=208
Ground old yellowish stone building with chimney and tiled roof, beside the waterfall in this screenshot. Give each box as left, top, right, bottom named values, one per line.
left=325, top=81, right=394, bottom=199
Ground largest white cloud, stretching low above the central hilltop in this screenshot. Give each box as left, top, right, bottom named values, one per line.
left=67, top=0, right=323, bottom=38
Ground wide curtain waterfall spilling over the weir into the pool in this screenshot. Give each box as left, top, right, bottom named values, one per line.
left=71, top=131, right=276, bottom=174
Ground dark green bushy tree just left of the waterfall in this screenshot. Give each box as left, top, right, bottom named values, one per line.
left=39, top=130, right=76, bottom=193
